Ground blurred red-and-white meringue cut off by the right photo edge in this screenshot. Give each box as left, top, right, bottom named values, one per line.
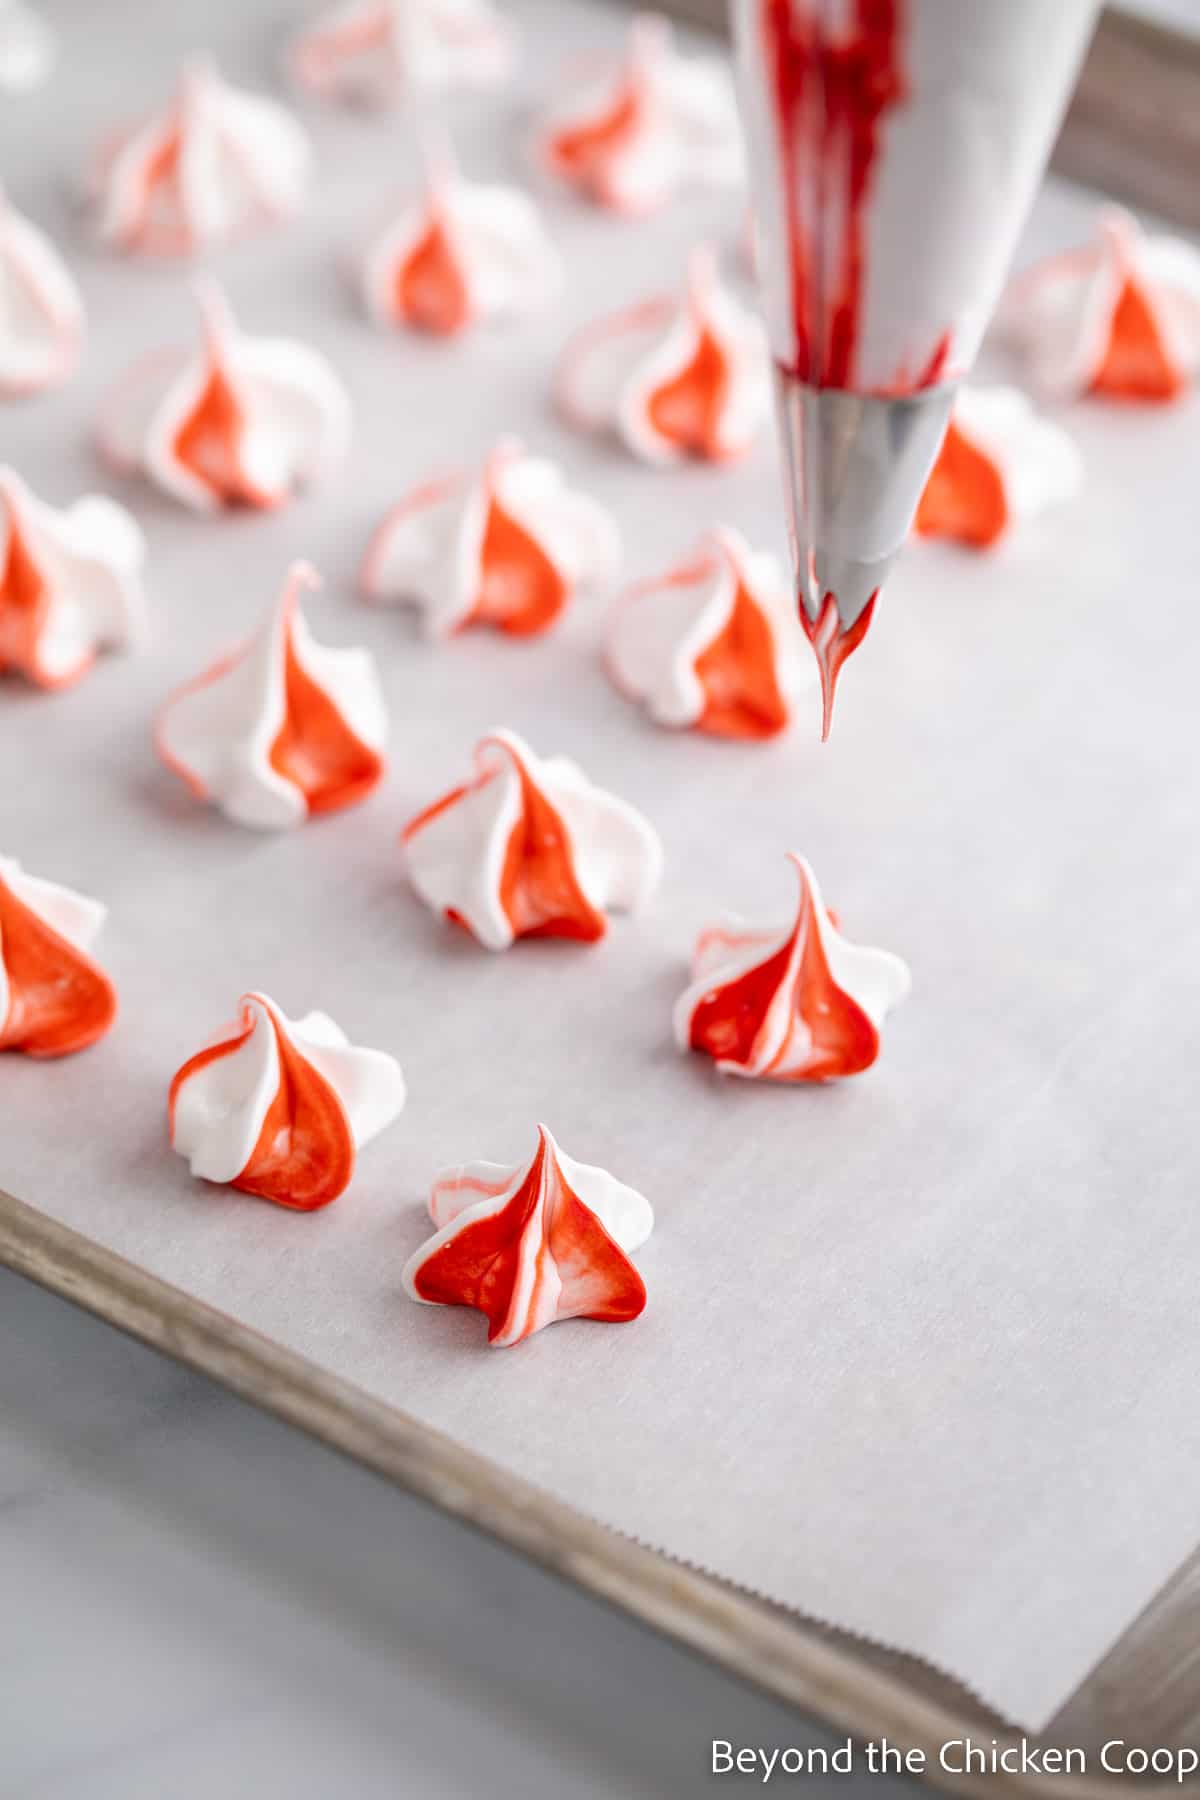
left=1000, top=207, right=1200, bottom=401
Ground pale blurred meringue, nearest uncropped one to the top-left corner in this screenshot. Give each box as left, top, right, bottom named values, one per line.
left=88, top=56, right=311, bottom=256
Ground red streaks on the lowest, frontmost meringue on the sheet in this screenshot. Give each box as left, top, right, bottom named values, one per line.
left=414, top=1132, right=646, bottom=1343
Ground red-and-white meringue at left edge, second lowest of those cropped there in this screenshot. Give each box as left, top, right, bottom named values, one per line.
left=0, top=468, right=146, bottom=688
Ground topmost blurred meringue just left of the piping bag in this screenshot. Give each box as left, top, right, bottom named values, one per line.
left=540, top=13, right=743, bottom=214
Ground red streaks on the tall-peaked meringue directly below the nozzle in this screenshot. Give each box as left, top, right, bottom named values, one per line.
left=689, top=869, right=880, bottom=1082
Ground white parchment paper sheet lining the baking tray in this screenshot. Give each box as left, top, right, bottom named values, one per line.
left=0, top=0, right=1200, bottom=1726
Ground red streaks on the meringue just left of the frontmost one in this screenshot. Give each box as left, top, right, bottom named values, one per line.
left=167, top=1008, right=354, bottom=1213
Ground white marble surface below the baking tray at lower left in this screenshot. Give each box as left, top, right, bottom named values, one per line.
left=0, top=1271, right=916, bottom=1800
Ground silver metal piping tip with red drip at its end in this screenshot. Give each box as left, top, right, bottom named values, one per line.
left=775, top=367, right=954, bottom=742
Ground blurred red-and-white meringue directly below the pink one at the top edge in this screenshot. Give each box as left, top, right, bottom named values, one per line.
left=362, top=153, right=563, bottom=337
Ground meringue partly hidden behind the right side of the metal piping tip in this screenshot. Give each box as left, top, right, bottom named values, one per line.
left=916, top=387, right=1083, bottom=549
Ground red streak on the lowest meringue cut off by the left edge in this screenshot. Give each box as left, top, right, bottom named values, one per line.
left=0, top=878, right=117, bottom=1057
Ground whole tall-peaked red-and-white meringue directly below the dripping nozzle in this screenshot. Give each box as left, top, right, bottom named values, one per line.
left=675, top=855, right=912, bottom=1082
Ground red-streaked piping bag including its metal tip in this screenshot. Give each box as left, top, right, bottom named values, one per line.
left=730, top=0, right=1097, bottom=738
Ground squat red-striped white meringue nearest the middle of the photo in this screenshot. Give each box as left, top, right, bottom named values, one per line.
left=401, top=731, right=662, bottom=950
